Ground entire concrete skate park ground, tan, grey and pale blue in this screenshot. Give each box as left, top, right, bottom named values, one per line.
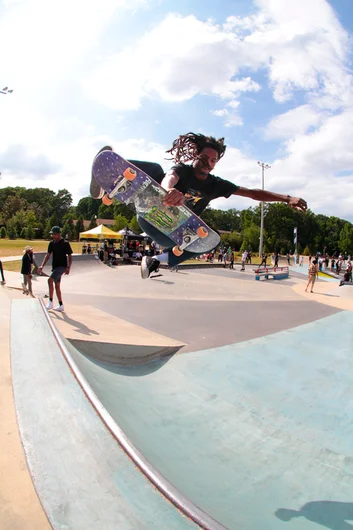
left=0, top=256, right=353, bottom=530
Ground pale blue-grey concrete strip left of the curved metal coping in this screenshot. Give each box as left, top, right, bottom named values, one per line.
left=11, top=300, right=196, bottom=530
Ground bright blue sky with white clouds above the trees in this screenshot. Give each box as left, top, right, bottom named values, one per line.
left=0, top=0, right=353, bottom=222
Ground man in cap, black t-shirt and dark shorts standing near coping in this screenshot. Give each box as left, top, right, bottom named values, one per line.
left=38, top=226, right=72, bottom=311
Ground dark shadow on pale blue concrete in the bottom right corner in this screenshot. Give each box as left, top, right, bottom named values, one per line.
left=275, top=501, right=353, bottom=530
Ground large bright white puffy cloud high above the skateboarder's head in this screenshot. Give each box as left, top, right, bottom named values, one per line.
left=85, top=15, right=260, bottom=110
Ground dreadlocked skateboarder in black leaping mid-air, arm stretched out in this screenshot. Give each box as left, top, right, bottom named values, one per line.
left=91, top=133, right=307, bottom=279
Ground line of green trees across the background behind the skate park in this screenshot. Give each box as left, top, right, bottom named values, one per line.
left=0, top=187, right=353, bottom=255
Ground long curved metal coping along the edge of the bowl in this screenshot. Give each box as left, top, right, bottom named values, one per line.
left=39, top=298, right=227, bottom=530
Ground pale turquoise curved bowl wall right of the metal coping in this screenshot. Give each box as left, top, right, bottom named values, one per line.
left=69, top=312, right=353, bottom=530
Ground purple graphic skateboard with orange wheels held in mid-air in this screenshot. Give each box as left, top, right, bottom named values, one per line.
left=92, top=151, right=220, bottom=256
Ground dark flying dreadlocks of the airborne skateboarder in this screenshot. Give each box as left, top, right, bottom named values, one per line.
left=167, top=133, right=227, bottom=164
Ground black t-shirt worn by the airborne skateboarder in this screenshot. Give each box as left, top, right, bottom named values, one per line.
left=172, top=164, right=239, bottom=215
